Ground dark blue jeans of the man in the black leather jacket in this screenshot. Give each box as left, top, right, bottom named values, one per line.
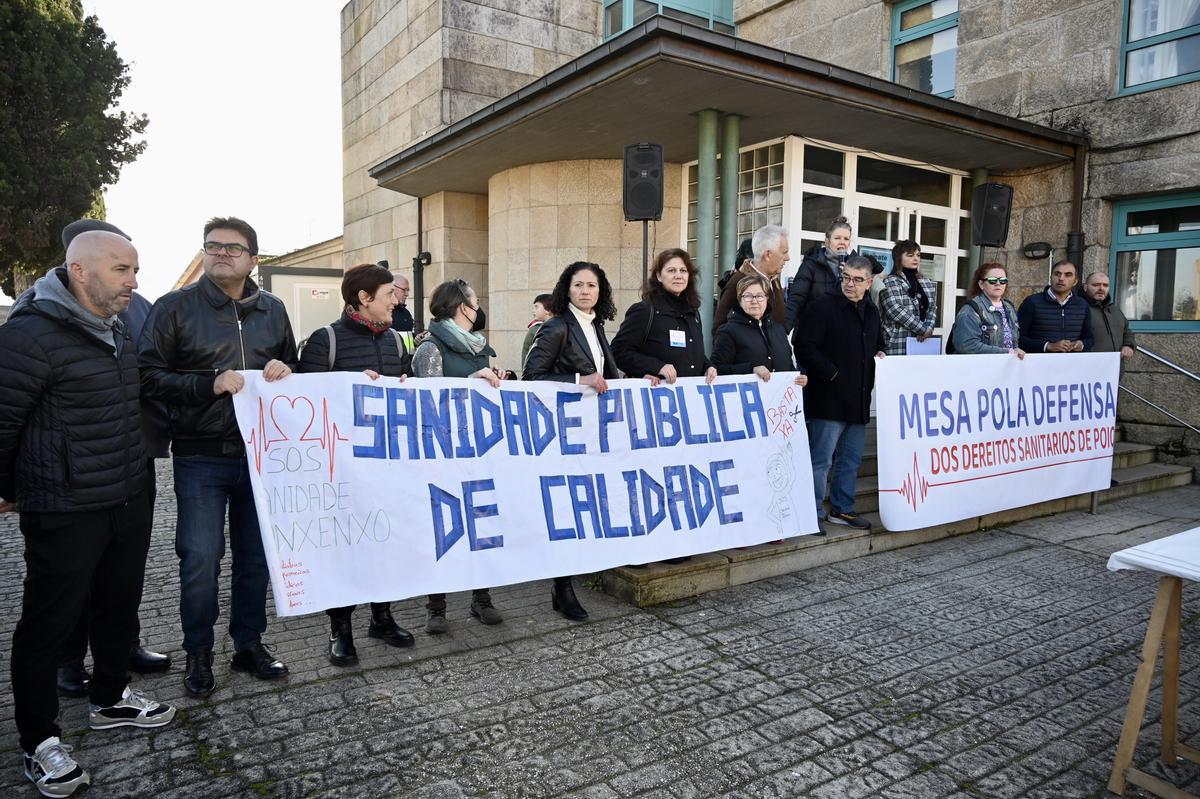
left=174, top=455, right=268, bottom=651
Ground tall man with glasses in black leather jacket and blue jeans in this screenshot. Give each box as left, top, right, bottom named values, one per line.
left=139, top=217, right=296, bottom=696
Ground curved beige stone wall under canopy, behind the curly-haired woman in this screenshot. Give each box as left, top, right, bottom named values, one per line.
left=487, top=160, right=683, bottom=371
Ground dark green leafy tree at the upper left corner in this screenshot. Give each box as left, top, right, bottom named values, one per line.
left=0, top=0, right=146, bottom=294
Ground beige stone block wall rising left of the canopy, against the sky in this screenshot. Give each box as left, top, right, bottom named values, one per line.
left=342, top=0, right=600, bottom=294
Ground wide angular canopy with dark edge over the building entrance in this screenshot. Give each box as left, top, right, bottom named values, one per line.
left=370, top=17, right=1086, bottom=197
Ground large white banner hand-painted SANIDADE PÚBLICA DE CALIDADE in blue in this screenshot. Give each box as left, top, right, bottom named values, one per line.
left=234, top=372, right=817, bottom=615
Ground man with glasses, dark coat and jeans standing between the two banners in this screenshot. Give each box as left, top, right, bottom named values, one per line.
left=792, top=256, right=886, bottom=530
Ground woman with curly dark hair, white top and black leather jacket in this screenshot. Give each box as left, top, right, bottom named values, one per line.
left=522, top=260, right=620, bottom=621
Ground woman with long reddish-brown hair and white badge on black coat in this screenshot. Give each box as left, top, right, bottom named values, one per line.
left=612, top=248, right=716, bottom=385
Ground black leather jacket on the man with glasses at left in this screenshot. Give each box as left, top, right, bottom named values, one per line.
left=138, top=276, right=296, bottom=457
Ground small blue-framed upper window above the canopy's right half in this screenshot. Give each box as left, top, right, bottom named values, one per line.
left=892, top=0, right=959, bottom=97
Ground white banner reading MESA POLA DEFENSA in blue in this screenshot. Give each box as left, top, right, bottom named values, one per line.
left=875, top=353, right=1121, bottom=530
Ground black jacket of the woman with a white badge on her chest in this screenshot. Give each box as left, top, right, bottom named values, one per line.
left=612, top=293, right=709, bottom=378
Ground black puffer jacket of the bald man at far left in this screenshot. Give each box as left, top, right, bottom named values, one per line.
left=0, top=268, right=146, bottom=513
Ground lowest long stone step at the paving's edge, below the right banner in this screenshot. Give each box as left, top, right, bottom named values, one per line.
left=600, top=458, right=1192, bottom=607
